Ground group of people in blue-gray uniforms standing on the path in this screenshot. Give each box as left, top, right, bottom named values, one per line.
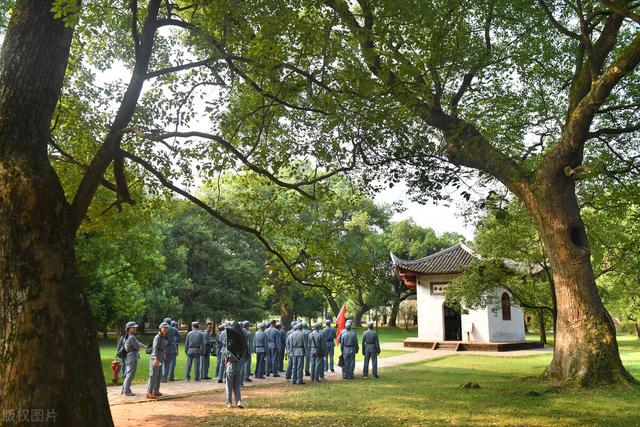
left=117, top=318, right=380, bottom=408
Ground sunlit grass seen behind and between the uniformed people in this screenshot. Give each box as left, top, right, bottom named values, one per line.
left=100, top=328, right=410, bottom=384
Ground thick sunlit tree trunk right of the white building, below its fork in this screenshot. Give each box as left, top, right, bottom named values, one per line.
left=525, top=176, right=634, bottom=386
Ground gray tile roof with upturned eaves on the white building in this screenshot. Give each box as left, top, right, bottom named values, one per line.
left=391, top=243, right=478, bottom=274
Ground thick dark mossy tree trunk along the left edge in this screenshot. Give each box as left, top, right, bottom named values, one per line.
left=0, top=0, right=113, bottom=426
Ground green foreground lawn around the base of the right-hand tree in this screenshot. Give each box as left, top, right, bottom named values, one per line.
left=200, top=336, right=640, bottom=426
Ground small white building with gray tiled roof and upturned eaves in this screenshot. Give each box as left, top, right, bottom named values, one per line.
left=391, top=243, right=537, bottom=351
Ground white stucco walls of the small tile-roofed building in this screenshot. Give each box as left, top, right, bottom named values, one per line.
left=416, top=275, right=524, bottom=342
